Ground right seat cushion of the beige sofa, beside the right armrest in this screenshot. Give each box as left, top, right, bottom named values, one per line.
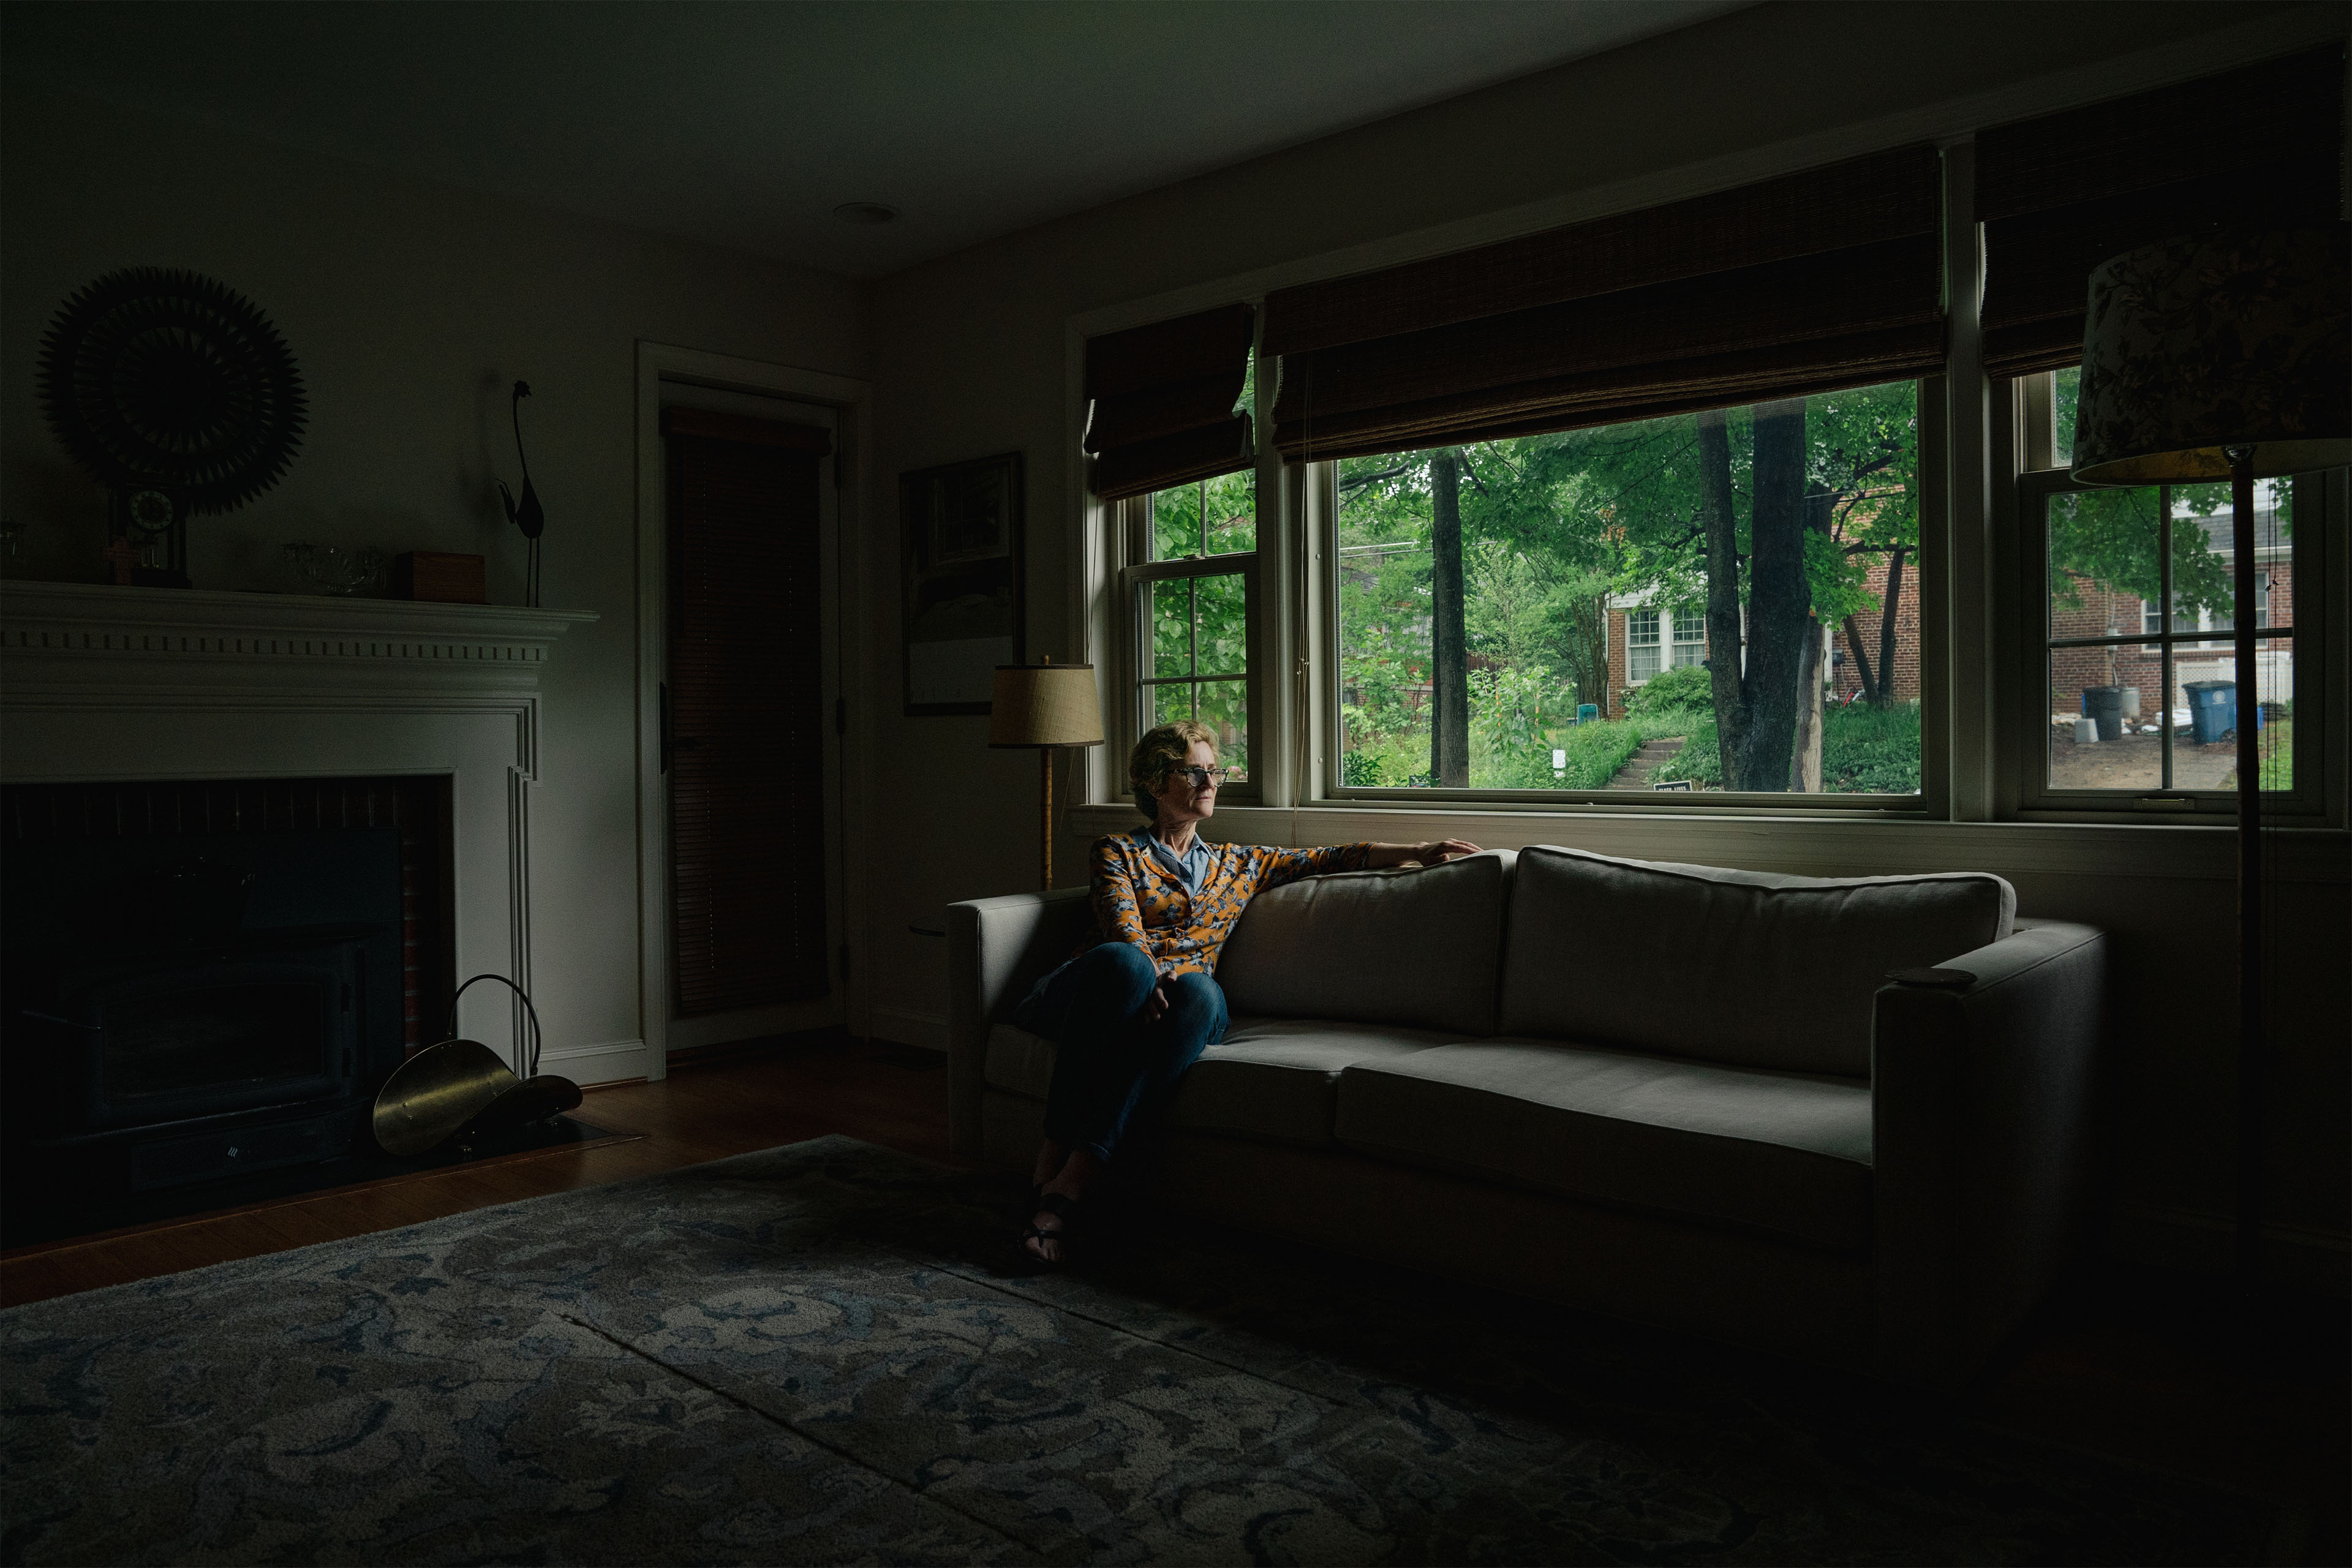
left=1336, top=1039, right=1870, bottom=1251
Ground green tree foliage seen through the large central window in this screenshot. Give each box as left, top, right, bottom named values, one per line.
left=1338, top=383, right=1919, bottom=788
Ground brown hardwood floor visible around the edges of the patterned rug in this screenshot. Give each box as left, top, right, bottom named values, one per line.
left=0, top=1039, right=2352, bottom=1563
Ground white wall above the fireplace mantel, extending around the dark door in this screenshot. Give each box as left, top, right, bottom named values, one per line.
left=0, top=89, right=868, bottom=1081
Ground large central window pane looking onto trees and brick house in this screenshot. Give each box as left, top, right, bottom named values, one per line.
left=1329, top=381, right=1924, bottom=797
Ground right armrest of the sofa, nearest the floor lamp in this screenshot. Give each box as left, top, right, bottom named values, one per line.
left=1870, top=922, right=2108, bottom=1389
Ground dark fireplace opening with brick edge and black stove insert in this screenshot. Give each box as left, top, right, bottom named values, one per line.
left=0, top=780, right=447, bottom=1227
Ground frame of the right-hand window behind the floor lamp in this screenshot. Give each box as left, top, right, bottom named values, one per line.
left=2002, top=442, right=2345, bottom=827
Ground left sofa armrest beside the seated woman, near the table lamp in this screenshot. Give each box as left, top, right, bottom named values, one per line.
left=948, top=889, right=1094, bottom=1159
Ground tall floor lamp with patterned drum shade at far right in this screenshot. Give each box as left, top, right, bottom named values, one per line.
left=2075, top=224, right=2352, bottom=1286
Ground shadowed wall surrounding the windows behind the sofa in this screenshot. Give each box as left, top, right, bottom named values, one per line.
left=870, top=5, right=2352, bottom=1270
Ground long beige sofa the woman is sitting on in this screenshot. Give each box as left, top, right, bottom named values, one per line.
left=948, top=849, right=2105, bottom=1387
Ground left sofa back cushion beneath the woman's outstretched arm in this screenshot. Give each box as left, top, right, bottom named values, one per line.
left=1216, top=851, right=1512, bottom=1037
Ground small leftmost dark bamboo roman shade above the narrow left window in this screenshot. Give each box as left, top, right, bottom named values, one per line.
left=1087, top=306, right=1256, bottom=501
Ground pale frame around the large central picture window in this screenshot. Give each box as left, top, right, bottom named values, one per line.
left=1308, top=376, right=1952, bottom=820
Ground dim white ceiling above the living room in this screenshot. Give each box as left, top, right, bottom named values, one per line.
left=0, top=0, right=1752, bottom=277
